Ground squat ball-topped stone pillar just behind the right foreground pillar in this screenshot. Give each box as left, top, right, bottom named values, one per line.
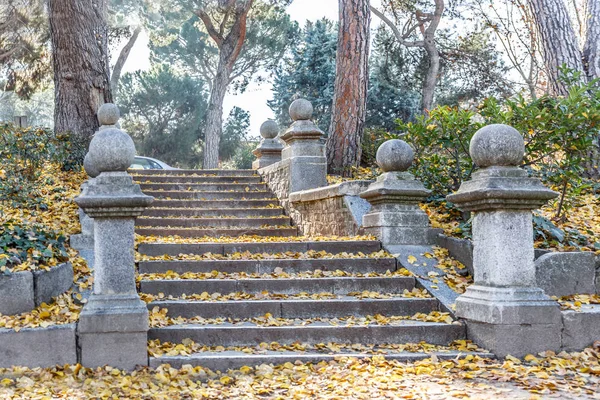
left=360, top=139, right=431, bottom=245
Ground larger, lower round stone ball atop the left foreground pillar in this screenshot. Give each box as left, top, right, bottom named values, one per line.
left=89, top=128, right=135, bottom=173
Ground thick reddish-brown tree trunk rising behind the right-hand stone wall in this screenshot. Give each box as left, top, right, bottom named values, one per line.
left=327, top=0, right=371, bottom=176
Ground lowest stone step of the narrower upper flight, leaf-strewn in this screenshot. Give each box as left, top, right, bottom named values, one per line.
left=135, top=227, right=298, bottom=238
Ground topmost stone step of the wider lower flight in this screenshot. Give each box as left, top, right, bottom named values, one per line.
left=138, top=240, right=381, bottom=256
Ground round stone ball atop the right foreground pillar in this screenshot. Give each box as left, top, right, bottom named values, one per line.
left=469, top=124, right=525, bottom=168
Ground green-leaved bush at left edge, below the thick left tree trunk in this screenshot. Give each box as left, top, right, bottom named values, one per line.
left=0, top=124, right=80, bottom=208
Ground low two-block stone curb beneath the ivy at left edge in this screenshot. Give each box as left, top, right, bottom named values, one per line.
left=0, top=262, right=73, bottom=315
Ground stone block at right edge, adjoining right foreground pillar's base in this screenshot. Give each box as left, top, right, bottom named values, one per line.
left=562, top=305, right=600, bottom=351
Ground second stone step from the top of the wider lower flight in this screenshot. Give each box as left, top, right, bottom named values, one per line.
left=138, top=258, right=396, bottom=274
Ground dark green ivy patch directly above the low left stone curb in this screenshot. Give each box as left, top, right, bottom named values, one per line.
left=0, top=221, right=69, bottom=274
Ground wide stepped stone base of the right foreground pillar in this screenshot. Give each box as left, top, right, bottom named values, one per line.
left=456, top=285, right=562, bottom=357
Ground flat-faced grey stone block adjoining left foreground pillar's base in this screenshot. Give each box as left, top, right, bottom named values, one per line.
left=0, top=324, right=77, bottom=368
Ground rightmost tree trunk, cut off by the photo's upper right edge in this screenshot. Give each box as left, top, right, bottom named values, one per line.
left=583, top=0, right=600, bottom=80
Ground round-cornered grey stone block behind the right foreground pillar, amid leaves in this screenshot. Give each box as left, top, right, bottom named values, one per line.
left=535, top=252, right=596, bottom=297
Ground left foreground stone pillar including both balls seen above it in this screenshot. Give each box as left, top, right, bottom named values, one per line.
left=75, top=104, right=153, bottom=370
